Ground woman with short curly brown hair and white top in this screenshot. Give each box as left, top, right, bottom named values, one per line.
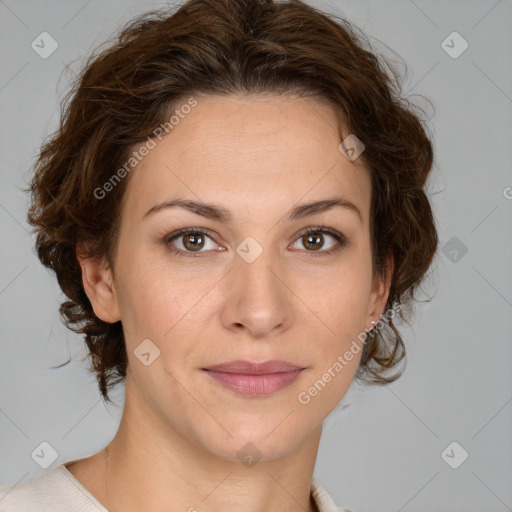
left=0, top=0, right=437, bottom=512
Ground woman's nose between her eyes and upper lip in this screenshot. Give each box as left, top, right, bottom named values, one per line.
left=221, top=242, right=293, bottom=338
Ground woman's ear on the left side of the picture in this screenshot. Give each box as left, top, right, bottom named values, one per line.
left=76, top=244, right=121, bottom=323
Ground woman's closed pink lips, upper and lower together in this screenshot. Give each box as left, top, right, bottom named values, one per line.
left=203, top=360, right=305, bottom=397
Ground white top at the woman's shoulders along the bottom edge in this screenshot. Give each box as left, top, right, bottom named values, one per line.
left=0, top=462, right=350, bottom=512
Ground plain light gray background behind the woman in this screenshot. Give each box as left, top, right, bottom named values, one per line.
left=0, top=0, right=512, bottom=512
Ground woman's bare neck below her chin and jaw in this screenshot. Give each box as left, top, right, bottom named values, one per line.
left=94, top=372, right=321, bottom=512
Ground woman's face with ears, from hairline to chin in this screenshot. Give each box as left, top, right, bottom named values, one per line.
left=82, top=96, right=388, bottom=460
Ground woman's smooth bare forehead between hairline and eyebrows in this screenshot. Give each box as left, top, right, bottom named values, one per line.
left=119, top=95, right=371, bottom=223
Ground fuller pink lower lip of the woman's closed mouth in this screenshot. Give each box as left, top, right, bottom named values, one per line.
left=202, top=369, right=302, bottom=396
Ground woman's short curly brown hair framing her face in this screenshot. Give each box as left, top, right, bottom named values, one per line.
left=26, top=0, right=438, bottom=401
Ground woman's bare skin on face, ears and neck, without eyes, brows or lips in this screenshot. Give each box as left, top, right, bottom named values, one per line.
left=68, top=95, right=392, bottom=512
